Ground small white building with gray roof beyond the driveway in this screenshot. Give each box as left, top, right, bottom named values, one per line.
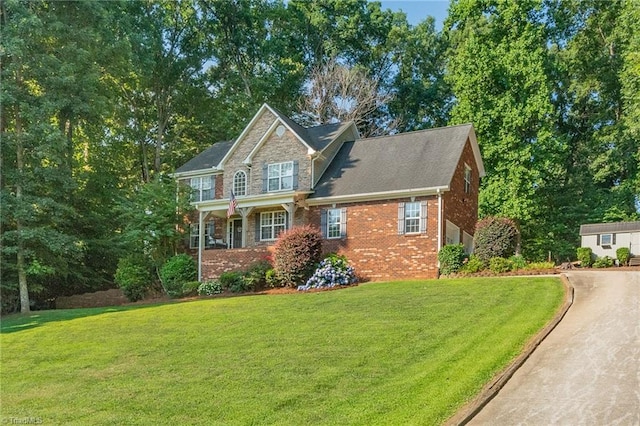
left=580, top=222, right=640, bottom=259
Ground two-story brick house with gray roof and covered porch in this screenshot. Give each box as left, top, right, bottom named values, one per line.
left=174, top=104, right=484, bottom=280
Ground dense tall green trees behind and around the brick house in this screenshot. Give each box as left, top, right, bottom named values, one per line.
left=0, top=0, right=640, bottom=311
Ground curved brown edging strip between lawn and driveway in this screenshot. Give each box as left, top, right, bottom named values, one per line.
left=445, top=274, right=575, bottom=426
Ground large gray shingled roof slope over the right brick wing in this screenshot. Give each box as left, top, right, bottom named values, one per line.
left=310, top=124, right=472, bottom=198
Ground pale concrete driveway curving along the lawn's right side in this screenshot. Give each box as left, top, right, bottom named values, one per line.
left=469, top=271, right=640, bottom=426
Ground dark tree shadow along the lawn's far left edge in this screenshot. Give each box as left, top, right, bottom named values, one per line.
left=0, top=303, right=168, bottom=334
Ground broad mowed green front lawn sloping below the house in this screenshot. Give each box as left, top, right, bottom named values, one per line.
left=0, top=277, right=563, bottom=425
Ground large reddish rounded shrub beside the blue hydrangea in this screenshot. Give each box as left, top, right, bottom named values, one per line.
left=273, top=226, right=322, bottom=287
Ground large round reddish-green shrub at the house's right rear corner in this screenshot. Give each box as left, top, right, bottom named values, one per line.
left=473, top=216, right=520, bottom=264
